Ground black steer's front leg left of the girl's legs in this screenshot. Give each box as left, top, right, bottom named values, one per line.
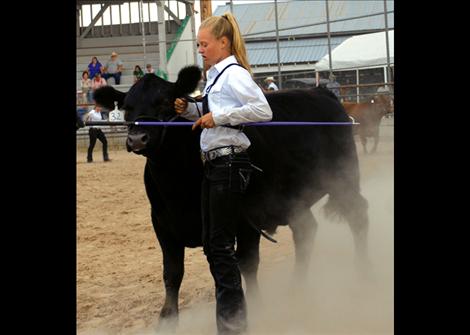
left=152, top=213, right=184, bottom=331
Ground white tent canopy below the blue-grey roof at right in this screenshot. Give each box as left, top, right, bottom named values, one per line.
left=314, top=30, right=394, bottom=71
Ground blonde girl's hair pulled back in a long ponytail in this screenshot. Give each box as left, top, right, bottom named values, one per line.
left=199, top=12, right=253, bottom=75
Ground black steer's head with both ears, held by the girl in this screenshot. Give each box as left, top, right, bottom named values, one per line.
left=95, top=66, right=201, bottom=156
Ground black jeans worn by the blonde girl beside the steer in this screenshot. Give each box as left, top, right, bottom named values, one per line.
left=202, top=152, right=251, bottom=335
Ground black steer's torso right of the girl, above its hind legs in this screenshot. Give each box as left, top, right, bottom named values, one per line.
left=245, top=88, right=359, bottom=230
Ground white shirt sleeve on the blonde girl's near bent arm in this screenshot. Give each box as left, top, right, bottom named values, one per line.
left=211, top=69, right=273, bottom=126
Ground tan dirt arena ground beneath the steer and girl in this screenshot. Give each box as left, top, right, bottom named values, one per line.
left=77, top=127, right=394, bottom=335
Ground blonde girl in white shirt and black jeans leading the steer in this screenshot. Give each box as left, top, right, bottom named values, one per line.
left=175, top=13, right=272, bottom=334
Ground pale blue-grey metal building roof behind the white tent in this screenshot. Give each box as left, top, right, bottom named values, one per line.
left=213, top=0, right=394, bottom=65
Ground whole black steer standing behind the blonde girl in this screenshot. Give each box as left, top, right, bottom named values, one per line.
left=95, top=66, right=368, bottom=330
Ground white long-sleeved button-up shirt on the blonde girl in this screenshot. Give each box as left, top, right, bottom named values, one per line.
left=181, top=55, right=273, bottom=152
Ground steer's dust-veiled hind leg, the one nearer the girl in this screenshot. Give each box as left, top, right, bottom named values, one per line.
left=289, top=207, right=318, bottom=279
